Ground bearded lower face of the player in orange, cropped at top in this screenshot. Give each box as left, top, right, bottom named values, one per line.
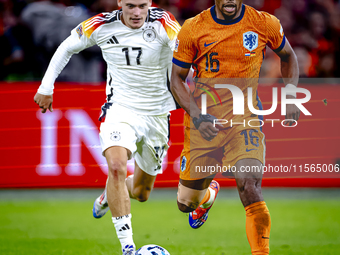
left=215, top=0, right=243, bottom=20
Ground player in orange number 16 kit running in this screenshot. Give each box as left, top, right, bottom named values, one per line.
left=171, top=0, right=300, bottom=255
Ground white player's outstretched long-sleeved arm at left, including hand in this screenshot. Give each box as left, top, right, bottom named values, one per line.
left=34, top=14, right=99, bottom=113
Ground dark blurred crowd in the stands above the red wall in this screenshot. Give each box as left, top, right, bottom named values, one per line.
left=0, top=0, right=340, bottom=83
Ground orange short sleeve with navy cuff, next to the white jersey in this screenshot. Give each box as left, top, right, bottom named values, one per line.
left=172, top=20, right=196, bottom=68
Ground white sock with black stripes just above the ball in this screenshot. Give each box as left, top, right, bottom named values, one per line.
left=112, top=213, right=136, bottom=248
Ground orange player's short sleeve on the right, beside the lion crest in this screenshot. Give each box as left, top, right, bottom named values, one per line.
left=264, top=13, right=286, bottom=52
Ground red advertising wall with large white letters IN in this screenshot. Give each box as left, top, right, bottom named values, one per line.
left=0, top=82, right=340, bottom=188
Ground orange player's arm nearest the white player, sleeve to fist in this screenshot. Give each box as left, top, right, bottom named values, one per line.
left=170, top=19, right=218, bottom=141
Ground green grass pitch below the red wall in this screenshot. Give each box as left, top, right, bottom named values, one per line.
left=0, top=189, right=340, bottom=255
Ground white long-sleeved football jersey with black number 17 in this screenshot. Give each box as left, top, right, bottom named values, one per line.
left=38, top=7, right=180, bottom=115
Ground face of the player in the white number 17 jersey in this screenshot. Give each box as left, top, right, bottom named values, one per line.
left=118, top=0, right=152, bottom=29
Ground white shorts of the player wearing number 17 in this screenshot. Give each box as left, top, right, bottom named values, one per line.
left=99, top=104, right=170, bottom=176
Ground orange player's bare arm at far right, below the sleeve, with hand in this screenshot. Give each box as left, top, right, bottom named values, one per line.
left=276, top=39, right=300, bottom=126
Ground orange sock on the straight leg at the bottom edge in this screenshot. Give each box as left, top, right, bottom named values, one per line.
left=244, top=201, right=271, bottom=255
